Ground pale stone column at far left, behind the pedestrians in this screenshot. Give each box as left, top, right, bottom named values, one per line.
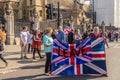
left=5, top=2, right=15, bottom=45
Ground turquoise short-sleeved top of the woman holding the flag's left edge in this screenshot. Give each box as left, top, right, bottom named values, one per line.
left=43, top=35, right=53, bottom=53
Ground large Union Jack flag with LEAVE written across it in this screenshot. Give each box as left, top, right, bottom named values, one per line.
left=51, top=38, right=107, bottom=75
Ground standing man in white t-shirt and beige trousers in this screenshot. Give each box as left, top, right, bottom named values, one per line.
left=20, top=26, right=29, bottom=59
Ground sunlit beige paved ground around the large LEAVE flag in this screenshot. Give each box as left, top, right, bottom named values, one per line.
left=0, top=43, right=120, bottom=80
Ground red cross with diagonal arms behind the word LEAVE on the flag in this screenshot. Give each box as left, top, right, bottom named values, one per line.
left=52, top=44, right=92, bottom=65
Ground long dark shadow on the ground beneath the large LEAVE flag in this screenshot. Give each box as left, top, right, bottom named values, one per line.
left=3, top=74, right=105, bottom=80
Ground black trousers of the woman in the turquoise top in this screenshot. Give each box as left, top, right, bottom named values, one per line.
left=45, top=52, right=52, bottom=73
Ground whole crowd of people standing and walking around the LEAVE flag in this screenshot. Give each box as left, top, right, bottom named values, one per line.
left=0, top=26, right=119, bottom=75
